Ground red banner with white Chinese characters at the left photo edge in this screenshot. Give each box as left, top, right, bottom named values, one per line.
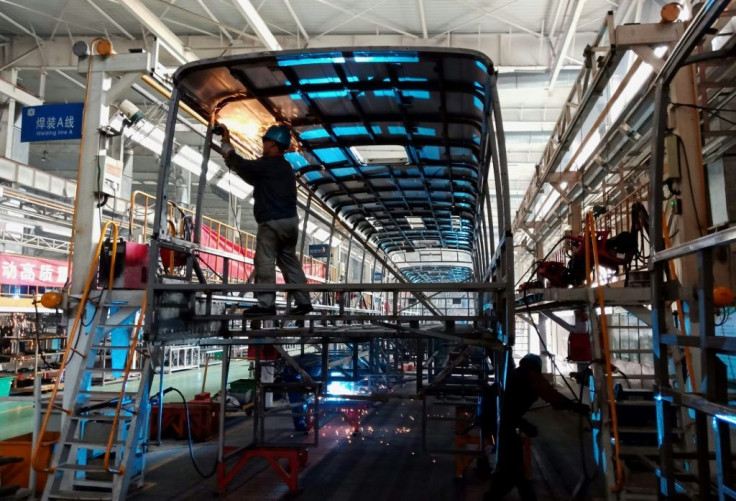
left=0, top=254, right=69, bottom=287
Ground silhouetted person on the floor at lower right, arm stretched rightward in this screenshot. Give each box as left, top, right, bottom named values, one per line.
left=483, top=353, right=590, bottom=501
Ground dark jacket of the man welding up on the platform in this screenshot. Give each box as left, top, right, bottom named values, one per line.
left=225, top=151, right=297, bottom=223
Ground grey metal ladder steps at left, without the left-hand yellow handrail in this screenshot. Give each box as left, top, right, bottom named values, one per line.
left=42, top=290, right=153, bottom=500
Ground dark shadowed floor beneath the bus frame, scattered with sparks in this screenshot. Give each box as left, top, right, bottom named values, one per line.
left=123, top=382, right=603, bottom=501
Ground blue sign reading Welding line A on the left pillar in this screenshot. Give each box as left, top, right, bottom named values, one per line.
left=20, top=103, right=84, bottom=143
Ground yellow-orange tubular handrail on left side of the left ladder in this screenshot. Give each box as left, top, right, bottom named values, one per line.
left=31, top=222, right=118, bottom=473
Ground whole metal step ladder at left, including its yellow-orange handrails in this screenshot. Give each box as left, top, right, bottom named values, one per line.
left=31, top=222, right=158, bottom=500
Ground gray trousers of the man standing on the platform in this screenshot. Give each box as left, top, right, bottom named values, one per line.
left=254, top=217, right=311, bottom=308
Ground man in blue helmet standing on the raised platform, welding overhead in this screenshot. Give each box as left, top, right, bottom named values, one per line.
left=222, top=125, right=313, bottom=316
